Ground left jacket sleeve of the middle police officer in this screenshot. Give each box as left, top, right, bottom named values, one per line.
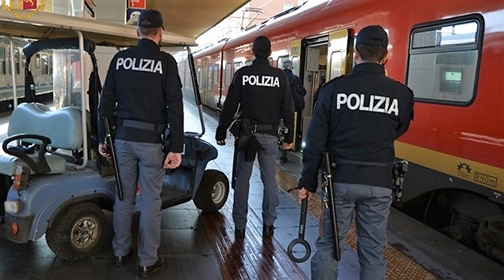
left=215, top=70, right=242, bottom=141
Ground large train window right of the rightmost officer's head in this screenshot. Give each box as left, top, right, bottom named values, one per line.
left=407, top=16, right=483, bottom=106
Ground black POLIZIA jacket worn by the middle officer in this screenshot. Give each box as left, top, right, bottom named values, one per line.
left=215, top=58, right=294, bottom=143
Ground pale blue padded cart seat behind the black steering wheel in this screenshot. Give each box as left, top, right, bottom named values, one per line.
left=0, top=102, right=83, bottom=176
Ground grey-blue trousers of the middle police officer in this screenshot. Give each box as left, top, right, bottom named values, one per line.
left=233, top=133, right=278, bottom=230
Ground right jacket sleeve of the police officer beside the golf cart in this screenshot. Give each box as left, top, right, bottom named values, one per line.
left=164, top=56, right=184, bottom=153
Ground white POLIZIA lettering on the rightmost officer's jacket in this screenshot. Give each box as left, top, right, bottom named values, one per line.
left=336, top=93, right=399, bottom=116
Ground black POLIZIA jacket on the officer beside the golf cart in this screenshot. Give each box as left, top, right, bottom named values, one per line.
left=98, top=39, right=184, bottom=152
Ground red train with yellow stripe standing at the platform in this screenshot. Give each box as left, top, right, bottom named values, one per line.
left=181, top=0, right=504, bottom=262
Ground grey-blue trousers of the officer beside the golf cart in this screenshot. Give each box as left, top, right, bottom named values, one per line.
left=112, top=139, right=165, bottom=266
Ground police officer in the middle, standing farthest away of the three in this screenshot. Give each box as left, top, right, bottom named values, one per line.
left=215, top=36, right=294, bottom=238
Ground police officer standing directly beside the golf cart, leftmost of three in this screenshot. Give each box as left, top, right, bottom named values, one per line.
left=98, top=10, right=183, bottom=277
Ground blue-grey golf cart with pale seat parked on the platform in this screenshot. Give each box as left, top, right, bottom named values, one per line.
left=0, top=25, right=229, bottom=261
